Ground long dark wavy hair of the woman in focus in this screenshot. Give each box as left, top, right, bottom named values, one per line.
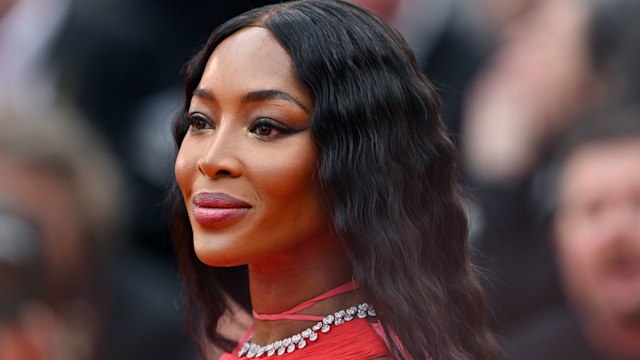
left=172, top=0, right=500, bottom=360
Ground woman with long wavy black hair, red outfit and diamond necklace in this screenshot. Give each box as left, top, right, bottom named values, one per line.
left=174, top=0, right=498, bottom=359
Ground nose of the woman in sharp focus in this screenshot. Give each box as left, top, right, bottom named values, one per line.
left=196, top=126, right=242, bottom=179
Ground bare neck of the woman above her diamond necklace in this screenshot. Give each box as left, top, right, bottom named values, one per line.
left=249, top=231, right=362, bottom=344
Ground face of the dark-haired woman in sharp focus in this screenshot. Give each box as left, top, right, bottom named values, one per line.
left=175, top=27, right=330, bottom=266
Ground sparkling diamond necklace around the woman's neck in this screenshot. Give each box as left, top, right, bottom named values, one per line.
left=238, top=303, right=376, bottom=359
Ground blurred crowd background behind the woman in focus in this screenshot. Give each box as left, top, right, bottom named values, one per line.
left=0, top=0, right=640, bottom=360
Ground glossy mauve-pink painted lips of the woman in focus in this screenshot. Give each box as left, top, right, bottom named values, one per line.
left=193, top=193, right=251, bottom=226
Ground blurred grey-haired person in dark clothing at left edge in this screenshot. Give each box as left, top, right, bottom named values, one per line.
left=0, top=107, right=193, bottom=360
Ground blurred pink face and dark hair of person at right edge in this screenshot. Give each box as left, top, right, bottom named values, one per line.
left=548, top=105, right=640, bottom=360
